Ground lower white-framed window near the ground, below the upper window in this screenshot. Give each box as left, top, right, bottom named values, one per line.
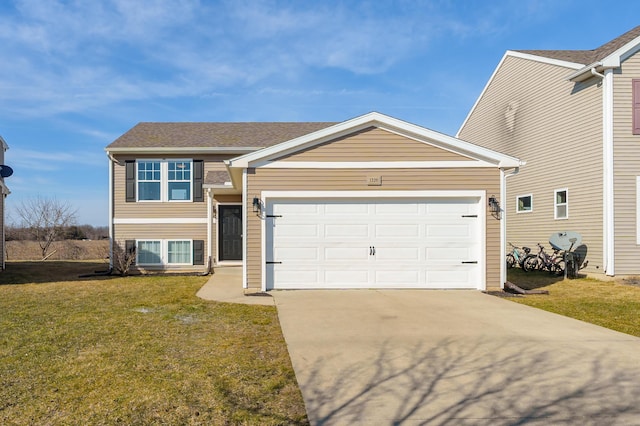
left=136, top=240, right=194, bottom=265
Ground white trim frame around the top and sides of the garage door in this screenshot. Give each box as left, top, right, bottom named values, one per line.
left=261, top=190, right=486, bottom=291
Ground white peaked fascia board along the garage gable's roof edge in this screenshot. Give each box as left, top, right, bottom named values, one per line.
left=227, top=112, right=522, bottom=168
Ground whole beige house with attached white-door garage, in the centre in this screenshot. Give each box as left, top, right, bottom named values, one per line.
left=106, top=113, right=521, bottom=290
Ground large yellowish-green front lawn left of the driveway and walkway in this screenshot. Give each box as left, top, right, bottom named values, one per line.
left=0, top=262, right=307, bottom=425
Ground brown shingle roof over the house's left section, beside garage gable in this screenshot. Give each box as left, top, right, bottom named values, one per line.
left=107, top=122, right=336, bottom=149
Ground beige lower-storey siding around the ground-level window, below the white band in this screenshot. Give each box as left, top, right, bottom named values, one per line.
left=114, top=223, right=207, bottom=272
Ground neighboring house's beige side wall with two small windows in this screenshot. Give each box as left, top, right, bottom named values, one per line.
left=458, top=57, right=603, bottom=273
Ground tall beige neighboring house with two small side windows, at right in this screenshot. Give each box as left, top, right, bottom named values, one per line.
left=457, top=26, right=640, bottom=276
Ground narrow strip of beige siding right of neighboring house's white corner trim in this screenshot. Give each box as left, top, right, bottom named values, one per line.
left=613, top=53, right=640, bottom=275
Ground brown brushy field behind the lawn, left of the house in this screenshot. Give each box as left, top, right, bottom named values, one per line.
left=5, top=240, right=109, bottom=262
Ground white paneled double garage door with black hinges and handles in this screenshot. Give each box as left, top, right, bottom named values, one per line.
left=265, top=198, right=482, bottom=289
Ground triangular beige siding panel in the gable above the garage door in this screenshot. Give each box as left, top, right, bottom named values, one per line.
left=272, top=127, right=471, bottom=161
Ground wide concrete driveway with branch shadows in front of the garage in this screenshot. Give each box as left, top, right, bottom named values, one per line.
left=271, top=290, right=640, bottom=425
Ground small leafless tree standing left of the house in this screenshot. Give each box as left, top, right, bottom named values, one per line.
left=16, top=196, right=76, bottom=260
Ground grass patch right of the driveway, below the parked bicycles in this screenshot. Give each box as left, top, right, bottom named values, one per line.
left=508, top=269, right=640, bottom=337
